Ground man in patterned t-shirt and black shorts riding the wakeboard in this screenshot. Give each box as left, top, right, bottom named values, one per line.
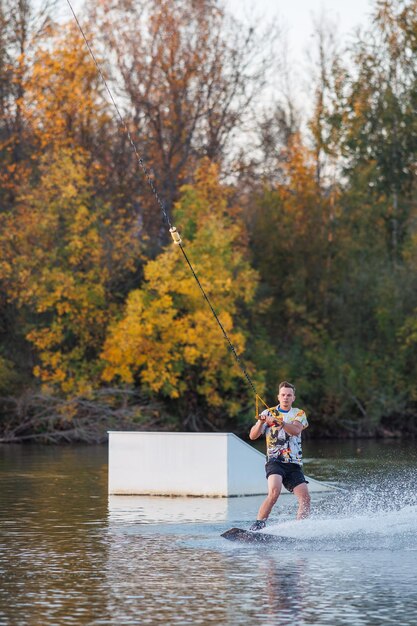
left=249, top=381, right=310, bottom=530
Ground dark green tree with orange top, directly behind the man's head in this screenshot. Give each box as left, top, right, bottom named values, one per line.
left=245, top=135, right=336, bottom=404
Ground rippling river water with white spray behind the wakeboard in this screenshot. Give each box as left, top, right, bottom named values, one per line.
left=0, top=441, right=417, bottom=626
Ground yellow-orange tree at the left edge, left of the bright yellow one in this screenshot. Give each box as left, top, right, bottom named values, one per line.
left=0, top=149, right=138, bottom=394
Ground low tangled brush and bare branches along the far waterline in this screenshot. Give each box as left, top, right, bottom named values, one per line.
left=0, top=389, right=416, bottom=444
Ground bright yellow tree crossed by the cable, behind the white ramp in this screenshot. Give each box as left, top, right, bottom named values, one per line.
left=102, top=160, right=262, bottom=430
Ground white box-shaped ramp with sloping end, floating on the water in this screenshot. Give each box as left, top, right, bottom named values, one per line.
left=109, top=432, right=332, bottom=497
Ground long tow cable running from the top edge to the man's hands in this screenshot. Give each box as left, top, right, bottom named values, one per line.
left=63, top=0, right=269, bottom=414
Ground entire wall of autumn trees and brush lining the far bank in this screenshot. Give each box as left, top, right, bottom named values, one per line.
left=0, top=0, right=417, bottom=442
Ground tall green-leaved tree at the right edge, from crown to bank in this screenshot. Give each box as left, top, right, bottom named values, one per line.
left=322, top=0, right=417, bottom=422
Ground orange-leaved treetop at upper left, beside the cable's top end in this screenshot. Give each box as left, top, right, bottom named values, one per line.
left=26, top=23, right=111, bottom=161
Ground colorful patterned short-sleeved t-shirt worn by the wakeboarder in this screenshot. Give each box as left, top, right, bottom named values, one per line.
left=262, top=406, right=308, bottom=465
